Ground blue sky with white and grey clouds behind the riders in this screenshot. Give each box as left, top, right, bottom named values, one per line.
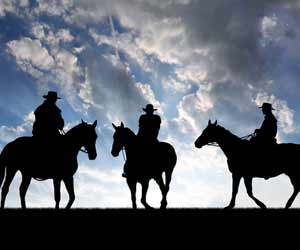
left=0, top=0, right=300, bottom=208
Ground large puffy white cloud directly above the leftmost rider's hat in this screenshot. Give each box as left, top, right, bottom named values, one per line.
left=7, top=34, right=87, bottom=111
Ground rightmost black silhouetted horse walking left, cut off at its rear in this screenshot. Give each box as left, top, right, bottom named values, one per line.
left=195, top=121, right=300, bottom=208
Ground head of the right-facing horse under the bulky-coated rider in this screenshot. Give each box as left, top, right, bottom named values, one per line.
left=79, top=120, right=98, bottom=160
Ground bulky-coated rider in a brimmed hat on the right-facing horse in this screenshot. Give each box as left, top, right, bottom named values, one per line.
left=32, top=91, right=64, bottom=139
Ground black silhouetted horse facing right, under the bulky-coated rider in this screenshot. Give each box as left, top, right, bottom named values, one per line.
left=0, top=121, right=97, bottom=208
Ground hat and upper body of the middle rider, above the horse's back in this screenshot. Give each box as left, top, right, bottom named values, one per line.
left=137, top=104, right=161, bottom=145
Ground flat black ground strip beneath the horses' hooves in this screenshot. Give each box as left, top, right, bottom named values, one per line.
left=0, top=208, right=300, bottom=246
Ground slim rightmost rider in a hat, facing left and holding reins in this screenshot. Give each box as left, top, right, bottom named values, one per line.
left=251, top=103, right=277, bottom=144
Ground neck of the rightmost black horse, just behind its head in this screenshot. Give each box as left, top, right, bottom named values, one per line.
left=217, top=127, right=241, bottom=158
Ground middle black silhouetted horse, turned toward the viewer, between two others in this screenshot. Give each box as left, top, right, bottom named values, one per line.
left=111, top=123, right=177, bottom=209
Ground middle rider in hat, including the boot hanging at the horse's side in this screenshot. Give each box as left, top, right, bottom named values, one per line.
left=122, top=104, right=161, bottom=177
